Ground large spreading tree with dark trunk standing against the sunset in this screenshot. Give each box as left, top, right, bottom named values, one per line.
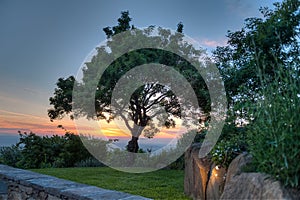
left=48, top=11, right=210, bottom=153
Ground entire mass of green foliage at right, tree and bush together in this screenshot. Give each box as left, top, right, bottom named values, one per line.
left=214, top=0, right=300, bottom=187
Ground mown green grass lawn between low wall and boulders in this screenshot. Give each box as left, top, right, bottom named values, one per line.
left=32, top=167, right=189, bottom=199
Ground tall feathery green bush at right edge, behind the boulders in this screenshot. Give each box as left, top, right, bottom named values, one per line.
left=248, top=68, right=300, bottom=187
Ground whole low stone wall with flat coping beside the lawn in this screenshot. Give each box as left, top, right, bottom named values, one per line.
left=0, top=165, right=147, bottom=200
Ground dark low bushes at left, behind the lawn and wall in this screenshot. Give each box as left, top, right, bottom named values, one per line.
left=0, top=132, right=106, bottom=169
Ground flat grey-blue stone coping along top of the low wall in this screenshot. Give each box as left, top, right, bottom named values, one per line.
left=0, top=164, right=148, bottom=200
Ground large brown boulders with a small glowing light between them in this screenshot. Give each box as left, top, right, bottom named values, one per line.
left=184, top=144, right=300, bottom=200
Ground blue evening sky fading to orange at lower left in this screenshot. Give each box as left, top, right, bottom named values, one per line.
left=0, top=0, right=282, bottom=145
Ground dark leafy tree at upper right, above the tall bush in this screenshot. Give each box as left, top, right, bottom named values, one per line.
left=213, top=0, right=300, bottom=118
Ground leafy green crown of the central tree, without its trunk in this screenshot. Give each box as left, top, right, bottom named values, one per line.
left=48, top=11, right=211, bottom=154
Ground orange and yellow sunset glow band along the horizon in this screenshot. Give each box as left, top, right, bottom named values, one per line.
left=0, top=109, right=188, bottom=138
